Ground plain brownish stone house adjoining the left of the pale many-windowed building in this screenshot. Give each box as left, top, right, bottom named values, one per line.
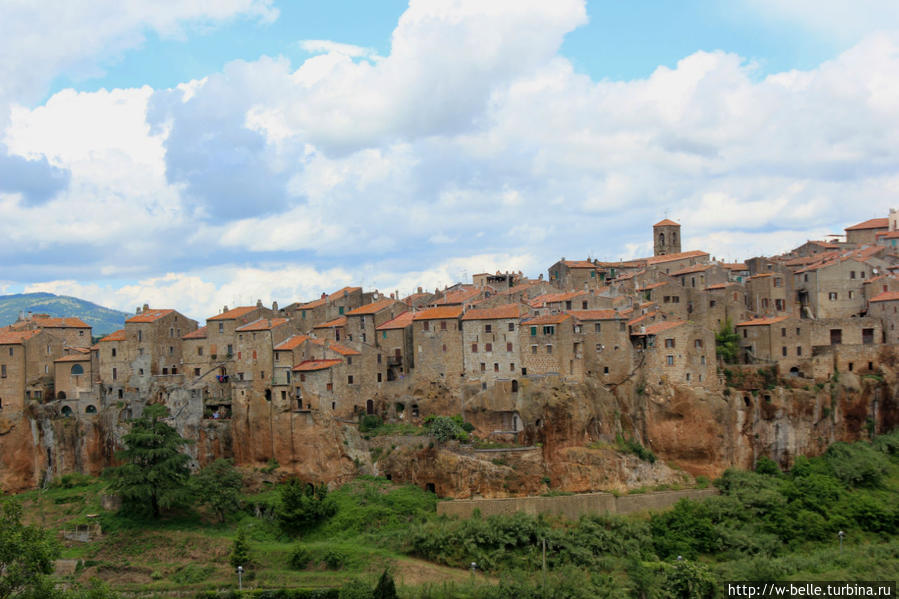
left=412, top=306, right=465, bottom=385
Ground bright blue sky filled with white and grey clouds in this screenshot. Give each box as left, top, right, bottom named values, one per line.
left=0, top=0, right=899, bottom=320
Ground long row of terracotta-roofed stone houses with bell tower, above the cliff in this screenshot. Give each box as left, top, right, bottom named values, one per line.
left=0, top=216, right=899, bottom=420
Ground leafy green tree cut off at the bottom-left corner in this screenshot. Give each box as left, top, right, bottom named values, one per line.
left=0, top=501, right=60, bottom=599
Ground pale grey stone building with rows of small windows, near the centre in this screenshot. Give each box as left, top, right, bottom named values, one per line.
left=462, top=304, right=526, bottom=388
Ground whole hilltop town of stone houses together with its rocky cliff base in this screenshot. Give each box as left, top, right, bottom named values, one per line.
left=0, top=217, right=899, bottom=496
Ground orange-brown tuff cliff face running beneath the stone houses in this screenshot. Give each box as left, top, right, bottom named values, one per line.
left=0, top=368, right=899, bottom=498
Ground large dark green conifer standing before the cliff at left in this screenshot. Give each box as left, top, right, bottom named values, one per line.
left=112, top=405, right=190, bottom=518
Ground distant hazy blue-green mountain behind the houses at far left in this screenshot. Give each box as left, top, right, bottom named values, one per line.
left=0, top=293, right=132, bottom=337
